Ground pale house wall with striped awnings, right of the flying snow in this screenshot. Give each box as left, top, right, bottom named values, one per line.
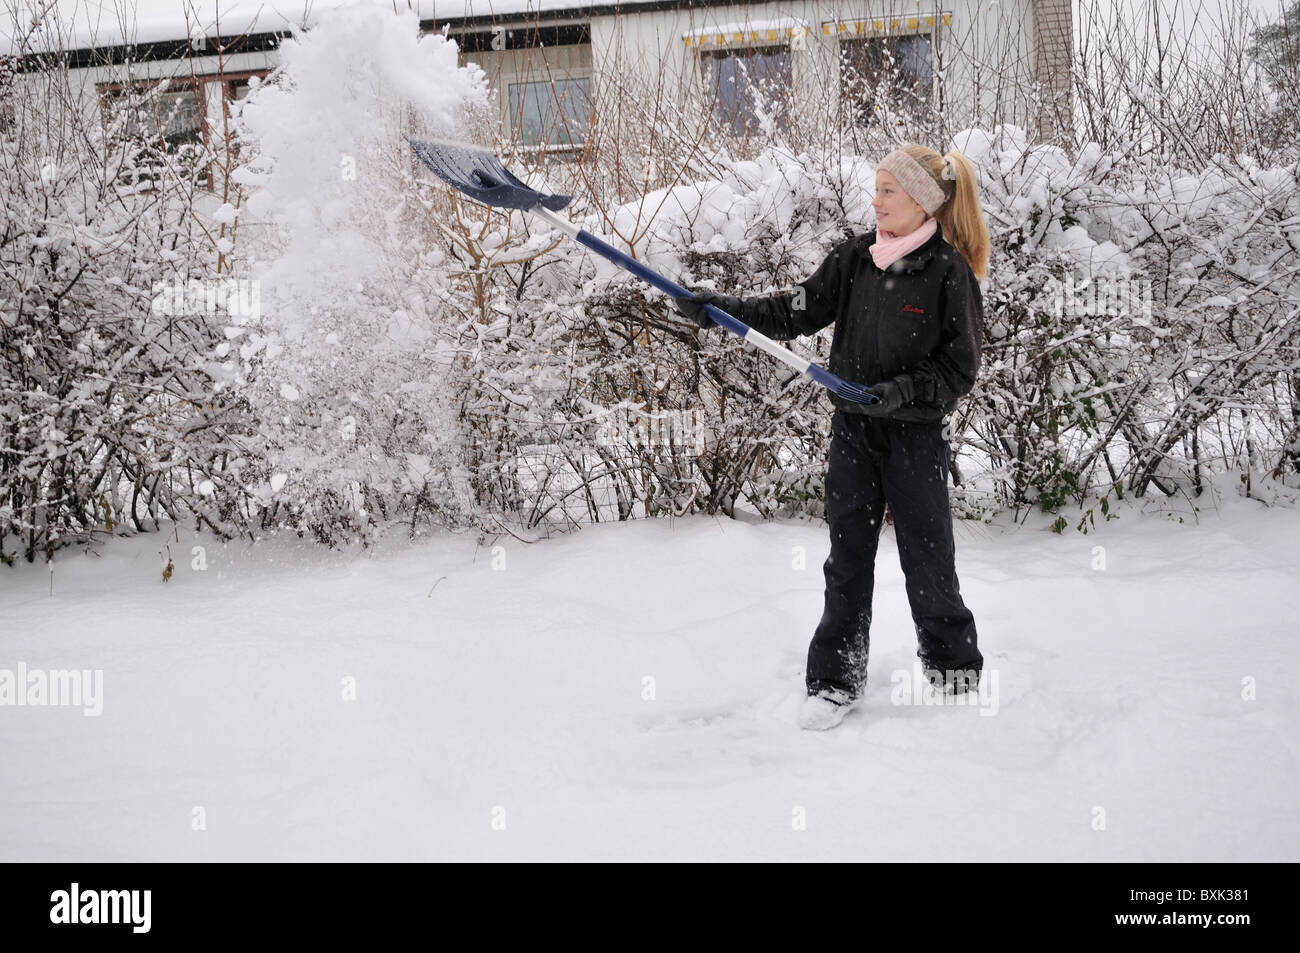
left=444, top=0, right=1074, bottom=148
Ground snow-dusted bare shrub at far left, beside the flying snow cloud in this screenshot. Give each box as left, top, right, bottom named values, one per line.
left=0, top=46, right=250, bottom=560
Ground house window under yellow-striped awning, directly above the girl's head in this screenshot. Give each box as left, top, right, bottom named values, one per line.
left=840, top=34, right=935, bottom=121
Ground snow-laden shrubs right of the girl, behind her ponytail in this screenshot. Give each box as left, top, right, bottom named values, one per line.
left=958, top=129, right=1300, bottom=510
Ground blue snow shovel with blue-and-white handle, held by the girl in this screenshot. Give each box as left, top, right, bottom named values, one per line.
left=407, top=139, right=880, bottom=404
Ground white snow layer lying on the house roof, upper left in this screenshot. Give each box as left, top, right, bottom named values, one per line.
left=0, top=0, right=654, bottom=53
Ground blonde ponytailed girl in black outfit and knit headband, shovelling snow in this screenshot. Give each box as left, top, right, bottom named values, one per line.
left=675, top=144, right=989, bottom=728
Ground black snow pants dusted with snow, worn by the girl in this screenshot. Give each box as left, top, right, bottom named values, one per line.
left=806, top=410, right=984, bottom=698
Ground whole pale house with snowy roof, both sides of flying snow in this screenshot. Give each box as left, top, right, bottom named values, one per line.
left=0, top=0, right=1073, bottom=185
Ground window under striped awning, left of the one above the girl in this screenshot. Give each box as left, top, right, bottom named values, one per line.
left=699, top=44, right=792, bottom=137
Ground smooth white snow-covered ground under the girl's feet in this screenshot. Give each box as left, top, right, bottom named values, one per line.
left=0, top=499, right=1300, bottom=861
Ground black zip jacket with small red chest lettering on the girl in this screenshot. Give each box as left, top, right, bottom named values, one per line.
left=735, top=221, right=984, bottom=421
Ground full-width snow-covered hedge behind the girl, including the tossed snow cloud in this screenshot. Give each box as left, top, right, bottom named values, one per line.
left=0, top=3, right=1300, bottom=558
